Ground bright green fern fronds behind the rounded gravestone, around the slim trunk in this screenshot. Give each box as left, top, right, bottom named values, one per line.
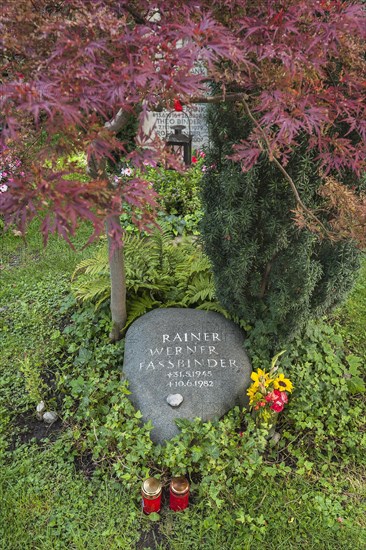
left=72, top=227, right=227, bottom=328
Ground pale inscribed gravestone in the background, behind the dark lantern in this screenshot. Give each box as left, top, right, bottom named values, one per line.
left=143, top=103, right=208, bottom=150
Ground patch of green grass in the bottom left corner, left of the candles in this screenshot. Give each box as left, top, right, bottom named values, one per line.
left=0, top=444, right=142, bottom=550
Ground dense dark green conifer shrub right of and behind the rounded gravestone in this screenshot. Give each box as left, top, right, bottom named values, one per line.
left=201, top=105, right=360, bottom=351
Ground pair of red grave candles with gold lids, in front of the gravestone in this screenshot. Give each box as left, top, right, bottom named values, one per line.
left=142, top=476, right=189, bottom=514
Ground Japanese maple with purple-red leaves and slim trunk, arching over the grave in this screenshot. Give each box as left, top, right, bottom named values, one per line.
left=0, top=0, right=366, bottom=338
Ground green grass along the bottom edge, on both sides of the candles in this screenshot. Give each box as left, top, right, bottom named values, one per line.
left=0, top=445, right=366, bottom=550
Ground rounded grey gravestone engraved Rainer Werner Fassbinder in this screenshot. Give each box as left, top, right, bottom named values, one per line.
left=123, top=308, right=252, bottom=443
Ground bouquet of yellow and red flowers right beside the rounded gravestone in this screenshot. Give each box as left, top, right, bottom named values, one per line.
left=247, top=351, right=293, bottom=426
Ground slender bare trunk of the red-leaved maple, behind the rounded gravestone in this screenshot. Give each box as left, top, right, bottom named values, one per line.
left=106, top=215, right=127, bottom=342
